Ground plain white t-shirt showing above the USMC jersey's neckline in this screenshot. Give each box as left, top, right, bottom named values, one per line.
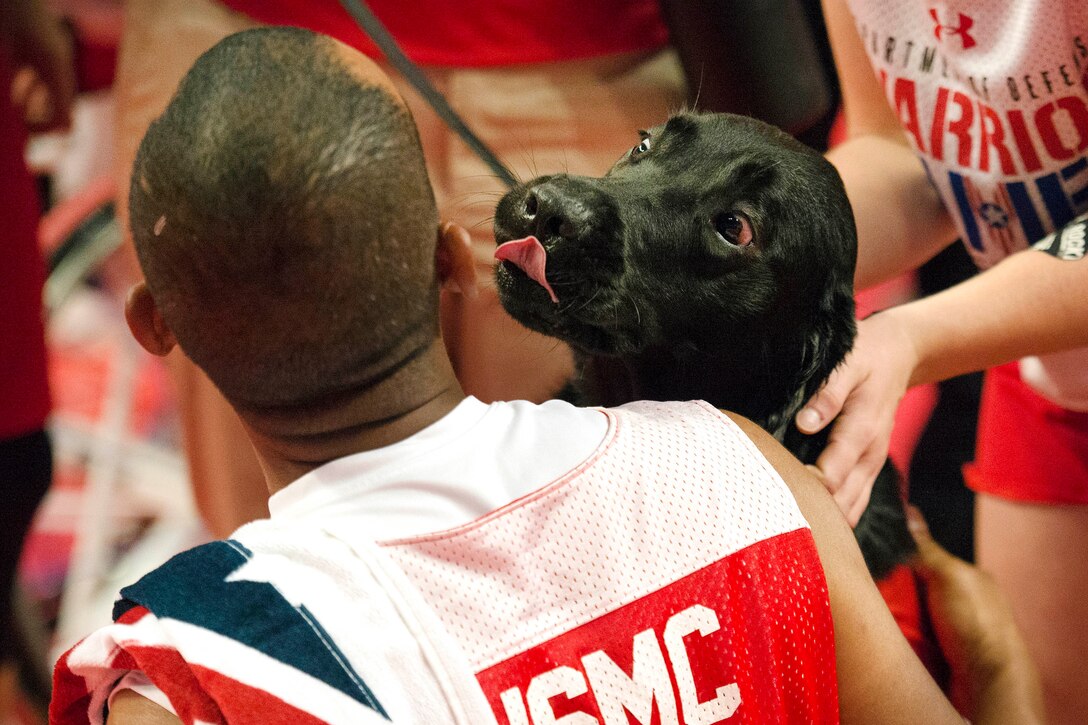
left=269, top=396, right=608, bottom=541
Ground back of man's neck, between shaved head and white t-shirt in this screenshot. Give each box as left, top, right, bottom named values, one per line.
left=239, top=340, right=465, bottom=493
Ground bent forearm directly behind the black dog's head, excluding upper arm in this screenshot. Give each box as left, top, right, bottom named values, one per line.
left=827, top=132, right=956, bottom=290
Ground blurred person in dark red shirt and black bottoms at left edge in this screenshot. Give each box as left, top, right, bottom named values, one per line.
left=0, top=0, right=75, bottom=720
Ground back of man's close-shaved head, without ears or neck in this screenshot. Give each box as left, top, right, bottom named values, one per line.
left=129, top=27, right=438, bottom=408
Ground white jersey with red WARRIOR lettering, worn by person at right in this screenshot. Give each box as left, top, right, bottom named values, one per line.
left=850, top=0, right=1088, bottom=409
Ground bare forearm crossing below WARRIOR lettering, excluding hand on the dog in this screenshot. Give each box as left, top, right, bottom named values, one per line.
left=883, top=249, right=1088, bottom=385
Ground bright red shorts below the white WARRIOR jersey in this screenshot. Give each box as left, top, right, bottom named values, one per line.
left=964, top=363, right=1088, bottom=504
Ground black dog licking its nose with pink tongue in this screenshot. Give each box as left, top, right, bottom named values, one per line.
left=495, top=113, right=914, bottom=578
